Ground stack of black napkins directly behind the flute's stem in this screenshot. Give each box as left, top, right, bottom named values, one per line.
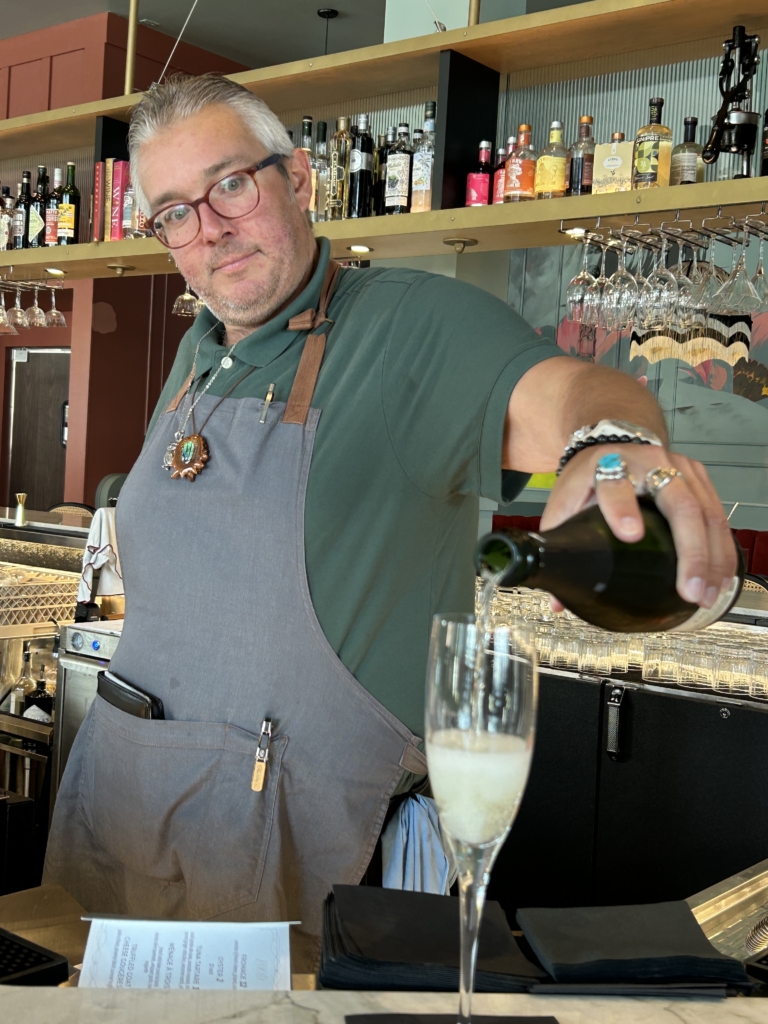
left=319, top=886, right=547, bottom=992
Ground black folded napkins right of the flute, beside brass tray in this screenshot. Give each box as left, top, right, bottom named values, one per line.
left=517, top=902, right=751, bottom=990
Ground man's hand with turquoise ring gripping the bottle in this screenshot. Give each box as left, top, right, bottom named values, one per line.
left=542, top=444, right=736, bottom=608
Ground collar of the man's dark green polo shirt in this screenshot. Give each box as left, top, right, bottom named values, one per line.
left=190, top=239, right=331, bottom=377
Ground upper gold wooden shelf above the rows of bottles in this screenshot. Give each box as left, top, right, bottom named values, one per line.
left=0, top=0, right=768, bottom=160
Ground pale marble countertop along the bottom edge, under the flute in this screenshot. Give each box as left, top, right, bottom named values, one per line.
left=0, top=986, right=768, bottom=1024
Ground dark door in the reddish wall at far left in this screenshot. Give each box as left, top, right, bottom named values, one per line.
left=5, top=348, right=70, bottom=512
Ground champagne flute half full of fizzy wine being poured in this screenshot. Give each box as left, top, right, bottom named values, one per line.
left=426, top=610, right=538, bottom=1024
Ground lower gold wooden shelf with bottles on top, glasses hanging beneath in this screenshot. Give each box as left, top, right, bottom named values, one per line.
left=0, top=177, right=768, bottom=282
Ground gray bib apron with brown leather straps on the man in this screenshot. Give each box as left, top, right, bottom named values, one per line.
left=45, top=263, right=426, bottom=971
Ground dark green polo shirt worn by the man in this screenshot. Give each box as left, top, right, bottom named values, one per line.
left=150, top=240, right=562, bottom=735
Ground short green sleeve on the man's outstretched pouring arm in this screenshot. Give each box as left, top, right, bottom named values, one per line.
left=382, top=273, right=563, bottom=504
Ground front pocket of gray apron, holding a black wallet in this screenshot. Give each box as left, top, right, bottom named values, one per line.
left=80, top=696, right=288, bottom=918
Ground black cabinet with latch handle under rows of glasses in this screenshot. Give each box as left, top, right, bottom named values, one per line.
left=488, top=671, right=768, bottom=922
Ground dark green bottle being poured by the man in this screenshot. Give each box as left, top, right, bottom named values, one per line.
left=475, top=499, right=744, bottom=633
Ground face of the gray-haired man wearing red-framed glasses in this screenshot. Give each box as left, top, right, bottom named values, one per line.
left=139, top=103, right=314, bottom=327
